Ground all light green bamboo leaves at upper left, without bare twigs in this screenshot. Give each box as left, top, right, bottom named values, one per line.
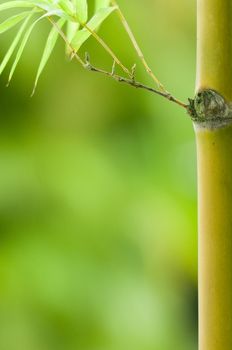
left=0, top=0, right=115, bottom=91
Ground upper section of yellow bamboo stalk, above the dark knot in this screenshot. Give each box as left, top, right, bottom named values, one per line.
left=196, top=0, right=232, bottom=101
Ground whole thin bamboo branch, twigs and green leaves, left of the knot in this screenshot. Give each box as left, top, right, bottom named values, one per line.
left=0, top=0, right=190, bottom=111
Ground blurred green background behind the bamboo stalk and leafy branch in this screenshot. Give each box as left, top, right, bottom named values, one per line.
left=0, top=0, right=197, bottom=350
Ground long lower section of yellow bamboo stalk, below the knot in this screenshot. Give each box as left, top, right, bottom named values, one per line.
left=196, top=125, right=232, bottom=350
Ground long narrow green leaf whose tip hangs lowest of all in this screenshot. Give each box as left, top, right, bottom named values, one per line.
left=32, top=18, right=65, bottom=95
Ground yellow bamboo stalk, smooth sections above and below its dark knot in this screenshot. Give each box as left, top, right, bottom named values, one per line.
left=195, top=0, right=232, bottom=350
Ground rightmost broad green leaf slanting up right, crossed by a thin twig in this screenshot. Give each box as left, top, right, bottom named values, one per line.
left=71, top=7, right=116, bottom=52
